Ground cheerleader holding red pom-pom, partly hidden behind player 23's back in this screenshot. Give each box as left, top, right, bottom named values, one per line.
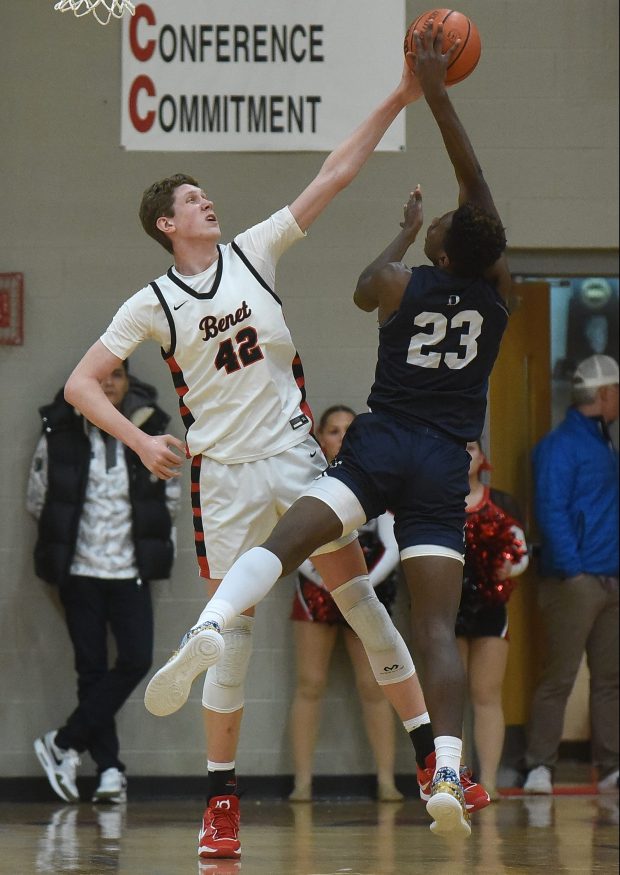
left=456, top=441, right=529, bottom=799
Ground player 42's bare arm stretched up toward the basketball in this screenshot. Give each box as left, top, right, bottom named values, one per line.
left=290, top=62, right=422, bottom=231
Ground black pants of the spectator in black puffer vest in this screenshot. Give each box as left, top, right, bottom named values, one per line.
left=56, top=577, right=153, bottom=772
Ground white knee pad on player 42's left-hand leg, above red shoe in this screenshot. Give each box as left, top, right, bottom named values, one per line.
left=202, top=615, right=254, bottom=714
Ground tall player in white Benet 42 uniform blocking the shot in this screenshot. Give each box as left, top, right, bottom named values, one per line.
left=65, top=53, right=484, bottom=858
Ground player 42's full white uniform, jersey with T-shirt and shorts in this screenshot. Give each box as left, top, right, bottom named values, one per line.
left=101, top=207, right=355, bottom=579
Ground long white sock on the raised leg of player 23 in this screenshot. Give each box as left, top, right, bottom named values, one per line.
left=196, top=547, right=282, bottom=629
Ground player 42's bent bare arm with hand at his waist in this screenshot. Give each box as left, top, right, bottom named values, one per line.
left=65, top=340, right=185, bottom=480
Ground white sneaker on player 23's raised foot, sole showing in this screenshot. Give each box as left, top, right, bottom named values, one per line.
left=144, top=622, right=224, bottom=717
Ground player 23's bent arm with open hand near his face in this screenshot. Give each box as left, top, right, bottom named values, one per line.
left=353, top=185, right=423, bottom=323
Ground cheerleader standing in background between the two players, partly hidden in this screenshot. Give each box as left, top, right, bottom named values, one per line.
left=289, top=404, right=403, bottom=802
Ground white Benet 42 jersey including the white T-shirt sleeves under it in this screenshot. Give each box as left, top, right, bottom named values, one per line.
left=101, top=207, right=311, bottom=465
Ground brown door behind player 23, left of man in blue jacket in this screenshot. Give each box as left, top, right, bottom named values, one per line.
left=488, top=283, right=551, bottom=725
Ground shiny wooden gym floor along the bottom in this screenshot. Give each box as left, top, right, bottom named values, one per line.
left=0, top=794, right=618, bottom=875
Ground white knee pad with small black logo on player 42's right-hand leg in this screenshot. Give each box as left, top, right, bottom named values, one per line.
left=332, top=577, right=415, bottom=686
